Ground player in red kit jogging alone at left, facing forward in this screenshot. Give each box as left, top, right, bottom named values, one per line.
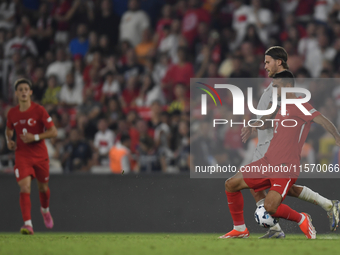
left=6, top=79, right=57, bottom=235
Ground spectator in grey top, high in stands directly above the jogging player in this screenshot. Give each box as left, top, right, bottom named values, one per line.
left=5, top=25, right=38, bottom=58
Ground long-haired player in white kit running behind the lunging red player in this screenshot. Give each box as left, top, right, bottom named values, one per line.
left=236, top=46, right=340, bottom=238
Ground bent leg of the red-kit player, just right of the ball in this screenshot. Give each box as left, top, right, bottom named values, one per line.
left=264, top=179, right=316, bottom=239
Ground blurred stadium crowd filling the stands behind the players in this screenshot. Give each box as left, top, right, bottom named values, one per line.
left=0, top=0, right=340, bottom=173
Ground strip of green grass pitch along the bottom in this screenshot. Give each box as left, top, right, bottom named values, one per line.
left=0, top=233, right=340, bottom=255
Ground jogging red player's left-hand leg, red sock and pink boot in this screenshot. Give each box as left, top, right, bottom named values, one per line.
left=18, top=175, right=34, bottom=234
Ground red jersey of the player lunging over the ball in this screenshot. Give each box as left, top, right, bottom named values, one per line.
left=264, top=103, right=320, bottom=165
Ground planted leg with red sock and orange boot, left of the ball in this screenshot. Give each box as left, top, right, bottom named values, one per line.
left=220, top=172, right=249, bottom=238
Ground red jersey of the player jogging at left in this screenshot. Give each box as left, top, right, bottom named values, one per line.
left=7, top=102, right=54, bottom=160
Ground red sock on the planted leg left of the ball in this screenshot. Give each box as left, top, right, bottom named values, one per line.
left=225, top=191, right=244, bottom=226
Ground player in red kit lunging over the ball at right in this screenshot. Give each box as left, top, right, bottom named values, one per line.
left=221, top=71, right=340, bottom=239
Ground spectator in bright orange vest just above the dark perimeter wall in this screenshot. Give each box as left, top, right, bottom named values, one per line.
left=109, top=134, right=132, bottom=174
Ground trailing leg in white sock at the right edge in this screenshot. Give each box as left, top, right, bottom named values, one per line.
left=288, top=184, right=340, bottom=231
